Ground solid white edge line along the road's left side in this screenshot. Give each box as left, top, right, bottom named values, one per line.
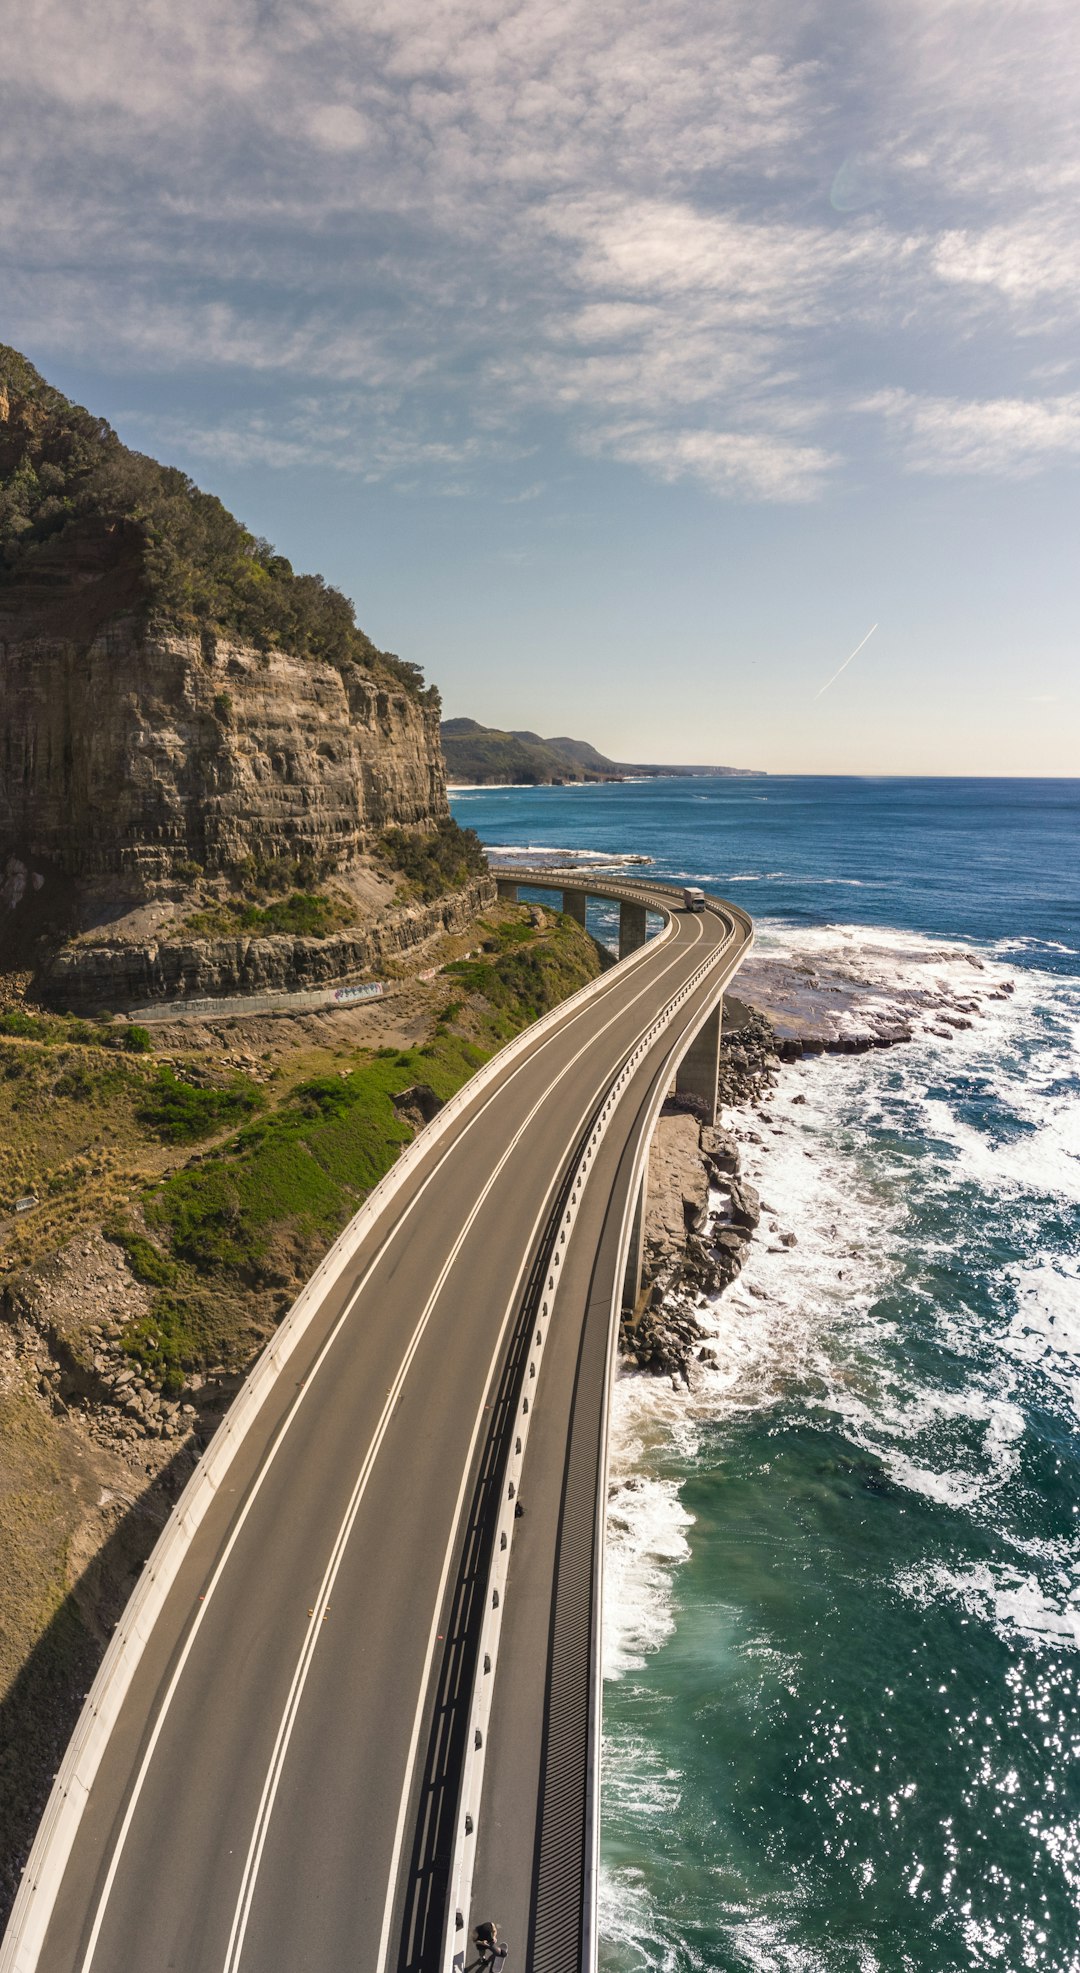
left=81, top=925, right=714, bottom=1973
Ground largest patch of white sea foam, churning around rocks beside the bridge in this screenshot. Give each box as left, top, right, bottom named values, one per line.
left=604, top=923, right=1080, bottom=1675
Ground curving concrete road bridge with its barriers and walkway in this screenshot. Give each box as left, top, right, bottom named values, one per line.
left=0, top=868, right=752, bottom=1973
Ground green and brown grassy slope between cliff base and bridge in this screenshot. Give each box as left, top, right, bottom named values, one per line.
left=0, top=906, right=598, bottom=1395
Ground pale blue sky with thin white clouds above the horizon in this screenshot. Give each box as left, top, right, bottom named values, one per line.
left=0, top=0, right=1080, bottom=775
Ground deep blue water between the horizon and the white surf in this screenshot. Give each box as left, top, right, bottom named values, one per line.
left=452, top=775, right=1080, bottom=973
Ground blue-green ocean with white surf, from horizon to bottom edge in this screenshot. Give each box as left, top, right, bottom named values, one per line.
left=452, top=777, right=1080, bottom=1973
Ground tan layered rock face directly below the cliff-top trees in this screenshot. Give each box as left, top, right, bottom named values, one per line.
left=0, top=618, right=446, bottom=890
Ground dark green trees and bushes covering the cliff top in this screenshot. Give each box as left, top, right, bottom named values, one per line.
left=0, top=343, right=434, bottom=698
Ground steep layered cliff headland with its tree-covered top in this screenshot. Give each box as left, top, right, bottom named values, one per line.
left=0, top=345, right=490, bottom=1012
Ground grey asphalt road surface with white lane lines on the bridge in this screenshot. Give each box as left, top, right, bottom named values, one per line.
left=23, top=884, right=748, bottom=1973
